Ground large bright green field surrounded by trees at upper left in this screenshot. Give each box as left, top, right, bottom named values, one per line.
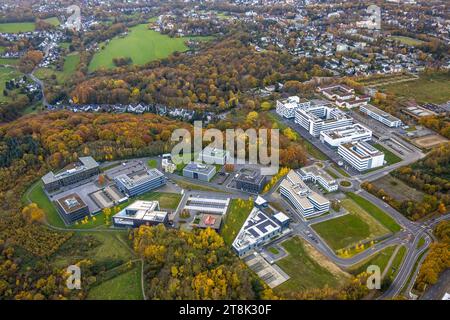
left=89, top=24, right=213, bottom=72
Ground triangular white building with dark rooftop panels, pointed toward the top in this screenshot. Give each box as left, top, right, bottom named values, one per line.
left=232, top=207, right=286, bottom=257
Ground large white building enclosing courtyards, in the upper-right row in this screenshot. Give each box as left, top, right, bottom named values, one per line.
left=295, top=105, right=353, bottom=137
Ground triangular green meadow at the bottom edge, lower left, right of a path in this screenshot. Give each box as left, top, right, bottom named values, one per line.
left=87, top=264, right=143, bottom=300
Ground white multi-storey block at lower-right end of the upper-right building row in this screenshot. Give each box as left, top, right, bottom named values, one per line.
left=338, top=141, right=384, bottom=171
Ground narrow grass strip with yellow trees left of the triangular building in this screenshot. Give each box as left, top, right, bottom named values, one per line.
left=221, top=199, right=253, bottom=246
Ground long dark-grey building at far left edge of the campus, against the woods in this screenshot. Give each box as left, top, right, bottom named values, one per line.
left=42, top=157, right=100, bottom=192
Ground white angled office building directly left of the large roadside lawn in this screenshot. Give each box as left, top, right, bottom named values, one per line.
left=279, top=170, right=330, bottom=218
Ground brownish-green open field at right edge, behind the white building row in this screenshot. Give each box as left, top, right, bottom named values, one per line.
left=382, top=73, right=450, bottom=104
